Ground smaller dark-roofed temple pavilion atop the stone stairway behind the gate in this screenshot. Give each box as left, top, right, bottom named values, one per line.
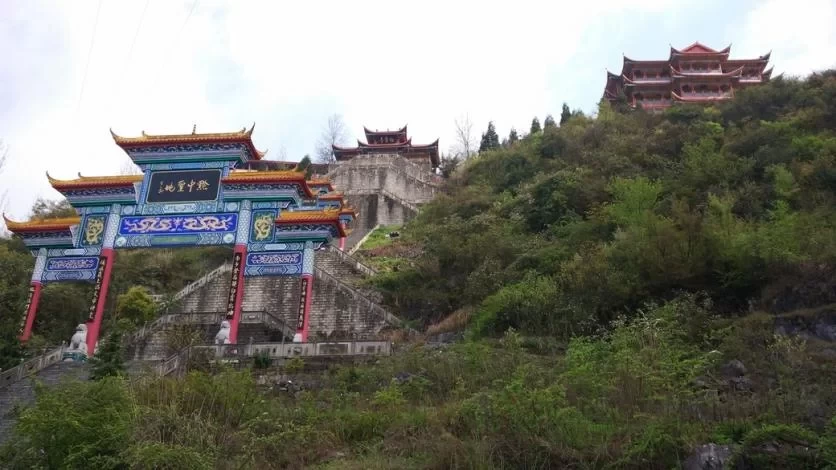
left=333, top=126, right=439, bottom=168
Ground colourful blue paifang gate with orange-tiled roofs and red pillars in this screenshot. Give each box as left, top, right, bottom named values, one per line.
left=6, top=126, right=356, bottom=354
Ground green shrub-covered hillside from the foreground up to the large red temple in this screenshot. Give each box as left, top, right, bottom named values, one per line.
left=0, top=72, right=836, bottom=469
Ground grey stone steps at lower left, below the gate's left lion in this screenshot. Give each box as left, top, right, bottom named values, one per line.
left=0, top=362, right=90, bottom=443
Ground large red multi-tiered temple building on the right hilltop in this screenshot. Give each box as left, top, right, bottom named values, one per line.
left=604, top=42, right=772, bottom=109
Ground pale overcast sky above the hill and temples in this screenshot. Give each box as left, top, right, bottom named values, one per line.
left=0, top=0, right=836, bottom=220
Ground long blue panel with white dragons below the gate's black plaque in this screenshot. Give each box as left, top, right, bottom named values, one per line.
left=119, top=213, right=238, bottom=235
